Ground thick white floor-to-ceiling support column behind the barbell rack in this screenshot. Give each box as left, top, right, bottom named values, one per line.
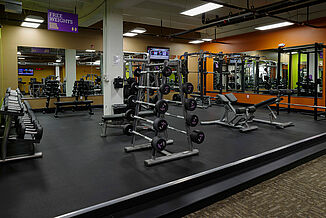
left=103, top=0, right=123, bottom=115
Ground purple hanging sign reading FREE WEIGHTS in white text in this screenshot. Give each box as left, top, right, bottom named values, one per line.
left=48, top=10, right=78, bottom=33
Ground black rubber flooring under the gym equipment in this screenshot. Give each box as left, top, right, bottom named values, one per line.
left=0, top=106, right=326, bottom=218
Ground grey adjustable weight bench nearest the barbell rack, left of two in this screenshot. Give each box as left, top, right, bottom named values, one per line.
left=200, top=93, right=258, bottom=132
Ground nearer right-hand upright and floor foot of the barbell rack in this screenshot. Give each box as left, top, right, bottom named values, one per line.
left=145, top=60, right=199, bottom=166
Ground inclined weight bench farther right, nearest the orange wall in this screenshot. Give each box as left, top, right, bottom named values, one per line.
left=252, top=97, right=294, bottom=129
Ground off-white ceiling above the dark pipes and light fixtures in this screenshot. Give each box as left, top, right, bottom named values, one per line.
left=23, top=0, right=326, bottom=38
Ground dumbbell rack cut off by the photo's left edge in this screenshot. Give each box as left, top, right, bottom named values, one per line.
left=0, top=88, right=43, bottom=163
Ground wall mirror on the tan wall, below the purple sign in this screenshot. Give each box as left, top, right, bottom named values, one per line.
left=17, top=46, right=102, bottom=98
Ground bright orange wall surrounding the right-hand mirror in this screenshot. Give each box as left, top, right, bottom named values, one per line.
left=201, top=18, right=326, bottom=110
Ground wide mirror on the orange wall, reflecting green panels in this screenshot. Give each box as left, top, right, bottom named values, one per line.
left=213, top=46, right=324, bottom=97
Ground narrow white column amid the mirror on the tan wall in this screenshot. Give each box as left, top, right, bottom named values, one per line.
left=65, top=49, right=76, bottom=96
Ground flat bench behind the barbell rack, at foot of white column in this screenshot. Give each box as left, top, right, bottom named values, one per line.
left=100, top=111, right=154, bottom=137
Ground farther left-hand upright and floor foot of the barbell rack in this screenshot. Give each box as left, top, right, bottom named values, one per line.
left=124, top=63, right=173, bottom=152
